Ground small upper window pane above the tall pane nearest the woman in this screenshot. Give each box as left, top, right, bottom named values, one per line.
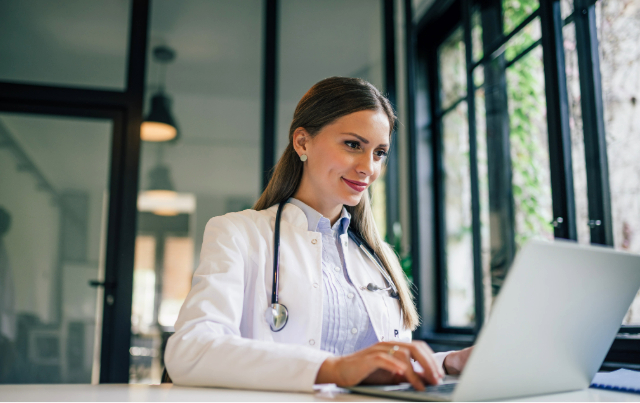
left=438, top=27, right=467, bottom=109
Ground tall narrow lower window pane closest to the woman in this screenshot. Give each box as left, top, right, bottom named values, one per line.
left=442, top=102, right=475, bottom=326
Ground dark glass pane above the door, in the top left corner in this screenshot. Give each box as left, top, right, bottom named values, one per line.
left=0, top=0, right=131, bottom=90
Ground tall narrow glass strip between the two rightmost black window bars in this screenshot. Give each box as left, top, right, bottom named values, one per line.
left=562, top=22, right=591, bottom=244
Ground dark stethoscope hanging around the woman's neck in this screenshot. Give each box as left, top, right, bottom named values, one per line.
left=264, top=201, right=400, bottom=332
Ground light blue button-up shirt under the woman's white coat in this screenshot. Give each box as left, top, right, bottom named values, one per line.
left=289, top=197, right=378, bottom=355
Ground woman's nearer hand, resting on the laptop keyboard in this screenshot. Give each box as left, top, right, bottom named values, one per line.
left=316, top=341, right=444, bottom=390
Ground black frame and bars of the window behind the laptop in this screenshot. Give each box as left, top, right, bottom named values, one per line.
left=404, top=0, right=640, bottom=369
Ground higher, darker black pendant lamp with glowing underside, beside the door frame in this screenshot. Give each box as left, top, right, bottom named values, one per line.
left=140, top=46, right=179, bottom=142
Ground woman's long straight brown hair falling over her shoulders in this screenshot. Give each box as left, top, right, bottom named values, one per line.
left=253, top=77, right=419, bottom=330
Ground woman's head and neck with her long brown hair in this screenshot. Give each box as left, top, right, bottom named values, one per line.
left=254, top=77, right=418, bottom=329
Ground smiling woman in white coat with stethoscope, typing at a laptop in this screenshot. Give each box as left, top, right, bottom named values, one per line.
left=165, top=77, right=476, bottom=391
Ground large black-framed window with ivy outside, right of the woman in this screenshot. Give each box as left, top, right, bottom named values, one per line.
left=414, top=0, right=640, bottom=362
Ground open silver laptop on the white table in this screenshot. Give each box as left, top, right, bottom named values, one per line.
left=348, top=241, right=640, bottom=401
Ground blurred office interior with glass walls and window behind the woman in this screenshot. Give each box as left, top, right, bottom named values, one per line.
left=0, top=0, right=640, bottom=384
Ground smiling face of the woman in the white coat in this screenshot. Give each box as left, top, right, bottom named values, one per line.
left=294, top=110, right=390, bottom=208
